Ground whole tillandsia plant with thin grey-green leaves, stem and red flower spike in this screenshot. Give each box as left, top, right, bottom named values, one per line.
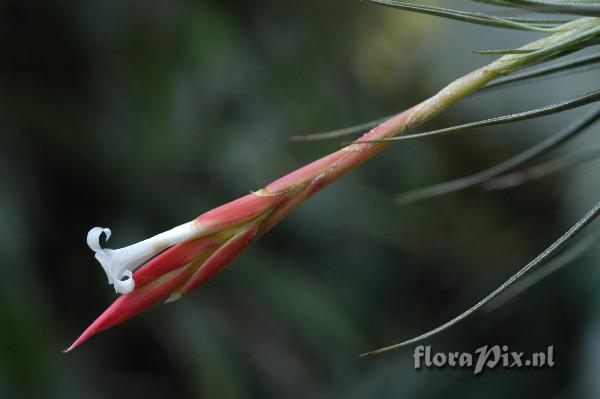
left=67, top=0, right=600, bottom=354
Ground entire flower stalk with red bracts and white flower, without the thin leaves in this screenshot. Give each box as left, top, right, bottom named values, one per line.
left=66, top=14, right=600, bottom=351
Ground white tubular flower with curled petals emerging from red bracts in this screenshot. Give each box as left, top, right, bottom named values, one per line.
left=87, top=221, right=199, bottom=294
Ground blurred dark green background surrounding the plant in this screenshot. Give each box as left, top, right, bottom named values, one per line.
left=0, top=0, right=600, bottom=399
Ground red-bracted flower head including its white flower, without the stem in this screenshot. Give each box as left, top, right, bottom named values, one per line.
left=67, top=194, right=282, bottom=351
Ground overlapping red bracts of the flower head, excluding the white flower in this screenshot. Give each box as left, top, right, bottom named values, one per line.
left=64, top=194, right=279, bottom=352
